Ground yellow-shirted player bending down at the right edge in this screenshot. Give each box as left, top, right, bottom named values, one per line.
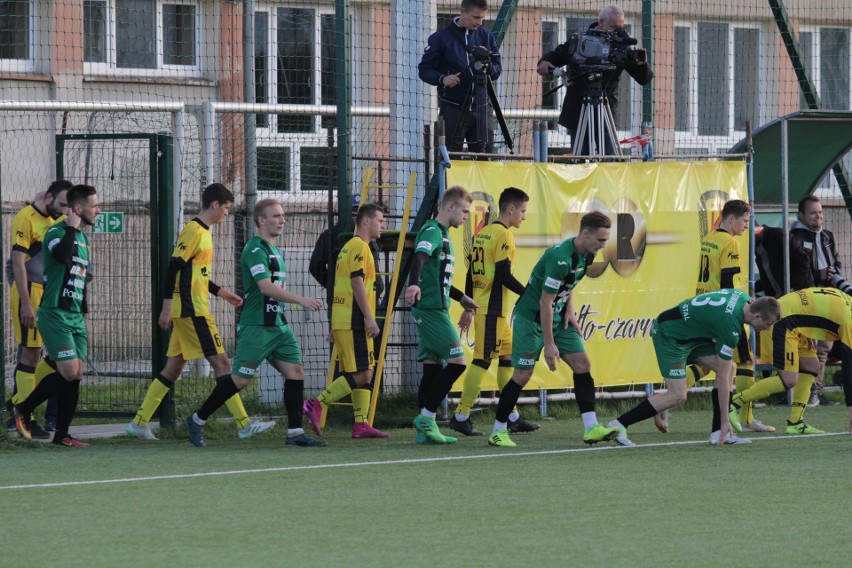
left=731, top=288, right=852, bottom=434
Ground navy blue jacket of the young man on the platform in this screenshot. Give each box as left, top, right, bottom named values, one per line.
left=417, top=19, right=503, bottom=106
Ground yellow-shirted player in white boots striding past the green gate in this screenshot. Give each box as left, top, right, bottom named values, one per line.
left=126, top=183, right=275, bottom=440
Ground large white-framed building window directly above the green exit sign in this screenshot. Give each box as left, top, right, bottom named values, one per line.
left=83, top=0, right=200, bottom=74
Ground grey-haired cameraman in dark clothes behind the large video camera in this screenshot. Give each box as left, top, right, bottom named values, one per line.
left=536, top=5, right=654, bottom=156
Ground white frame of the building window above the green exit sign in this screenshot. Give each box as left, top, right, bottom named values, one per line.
left=83, top=0, right=204, bottom=78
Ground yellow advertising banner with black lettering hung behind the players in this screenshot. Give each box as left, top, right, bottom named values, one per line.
left=447, top=162, right=750, bottom=390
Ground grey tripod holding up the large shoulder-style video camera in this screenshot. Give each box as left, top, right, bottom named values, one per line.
left=571, top=71, right=622, bottom=156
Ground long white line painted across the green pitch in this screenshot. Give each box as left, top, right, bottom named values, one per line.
left=0, top=432, right=848, bottom=491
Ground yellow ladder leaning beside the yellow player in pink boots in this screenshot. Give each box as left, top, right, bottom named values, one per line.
left=321, top=166, right=417, bottom=427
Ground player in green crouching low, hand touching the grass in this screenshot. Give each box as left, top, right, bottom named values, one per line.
left=607, top=288, right=781, bottom=446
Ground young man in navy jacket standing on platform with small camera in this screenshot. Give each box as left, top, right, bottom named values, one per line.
left=418, top=0, right=502, bottom=153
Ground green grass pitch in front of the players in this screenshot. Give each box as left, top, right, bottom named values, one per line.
left=0, top=404, right=852, bottom=567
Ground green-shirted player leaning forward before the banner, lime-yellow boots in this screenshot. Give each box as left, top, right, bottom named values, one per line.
left=488, top=211, right=618, bottom=447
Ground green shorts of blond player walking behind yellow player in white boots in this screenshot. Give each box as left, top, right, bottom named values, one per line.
left=231, top=325, right=302, bottom=379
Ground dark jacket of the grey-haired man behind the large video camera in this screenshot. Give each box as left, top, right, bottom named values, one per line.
left=541, top=22, right=654, bottom=134
